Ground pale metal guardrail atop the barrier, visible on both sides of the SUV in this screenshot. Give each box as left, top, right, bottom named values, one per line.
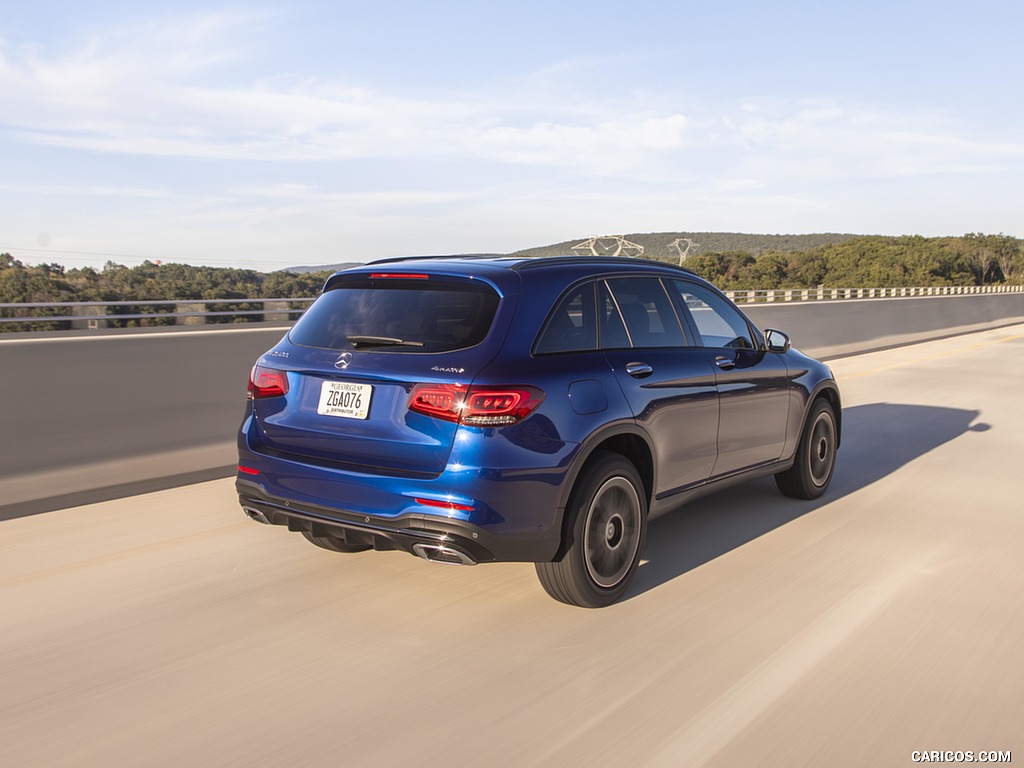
left=0, top=285, right=1024, bottom=329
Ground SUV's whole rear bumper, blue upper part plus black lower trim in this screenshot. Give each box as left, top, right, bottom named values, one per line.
left=236, top=415, right=579, bottom=563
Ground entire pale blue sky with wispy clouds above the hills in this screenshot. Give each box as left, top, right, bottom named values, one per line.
left=0, top=0, right=1024, bottom=270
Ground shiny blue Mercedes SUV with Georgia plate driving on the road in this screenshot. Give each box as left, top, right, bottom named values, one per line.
left=237, top=256, right=842, bottom=607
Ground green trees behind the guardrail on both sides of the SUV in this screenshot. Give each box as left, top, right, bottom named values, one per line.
left=0, top=232, right=1024, bottom=332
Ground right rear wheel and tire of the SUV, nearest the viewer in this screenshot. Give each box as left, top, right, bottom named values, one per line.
left=535, top=453, right=647, bottom=608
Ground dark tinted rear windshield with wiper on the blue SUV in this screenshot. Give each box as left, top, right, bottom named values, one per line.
left=289, top=276, right=499, bottom=352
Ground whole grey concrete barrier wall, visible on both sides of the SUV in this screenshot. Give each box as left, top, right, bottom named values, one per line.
left=0, top=294, right=1024, bottom=519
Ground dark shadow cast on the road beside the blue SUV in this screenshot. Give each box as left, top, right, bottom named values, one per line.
left=627, top=402, right=990, bottom=599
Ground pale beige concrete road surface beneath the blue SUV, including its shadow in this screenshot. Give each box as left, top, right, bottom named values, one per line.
left=0, top=326, right=1024, bottom=768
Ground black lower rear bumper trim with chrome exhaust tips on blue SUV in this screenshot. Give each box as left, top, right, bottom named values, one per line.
left=236, top=476, right=560, bottom=565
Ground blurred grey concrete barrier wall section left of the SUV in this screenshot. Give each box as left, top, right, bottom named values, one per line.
left=0, top=326, right=286, bottom=519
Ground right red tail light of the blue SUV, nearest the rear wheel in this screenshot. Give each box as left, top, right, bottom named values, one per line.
left=409, top=384, right=544, bottom=427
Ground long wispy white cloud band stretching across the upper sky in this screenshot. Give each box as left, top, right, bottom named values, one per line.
left=0, top=11, right=1024, bottom=189
